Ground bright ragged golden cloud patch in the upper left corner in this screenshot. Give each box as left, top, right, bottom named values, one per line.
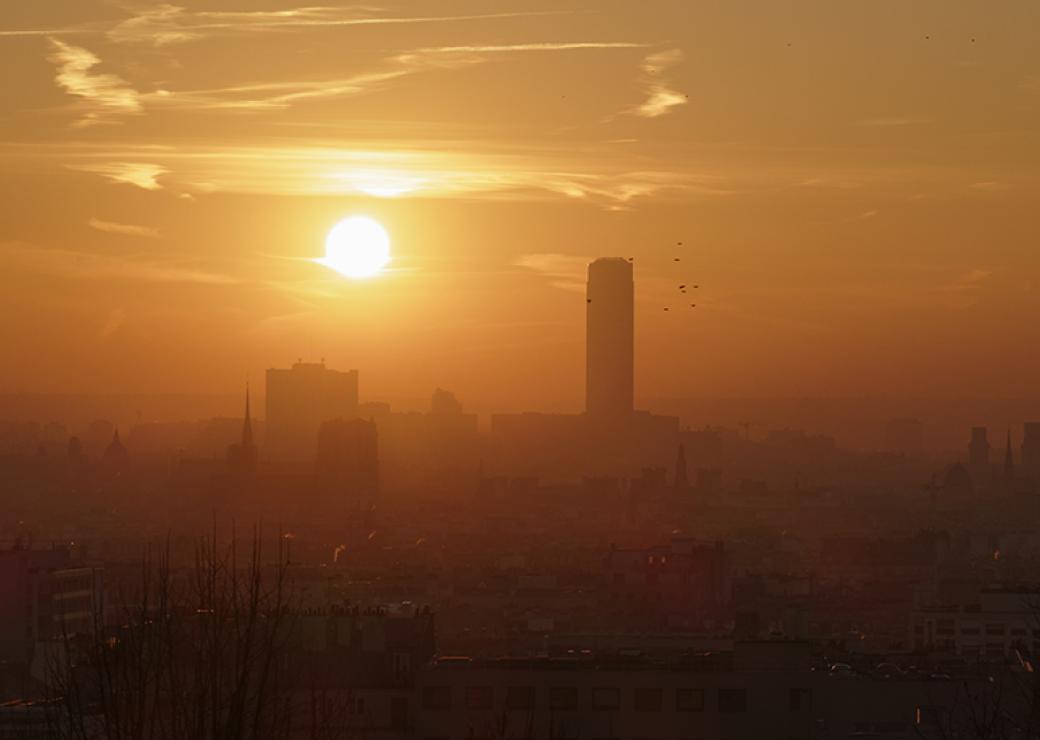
left=49, top=38, right=141, bottom=126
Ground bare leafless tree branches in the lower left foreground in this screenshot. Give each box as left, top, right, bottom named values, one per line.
left=49, top=529, right=346, bottom=740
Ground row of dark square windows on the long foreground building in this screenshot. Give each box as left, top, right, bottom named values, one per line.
left=422, top=686, right=812, bottom=713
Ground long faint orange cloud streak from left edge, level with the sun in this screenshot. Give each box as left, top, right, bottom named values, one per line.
left=0, top=242, right=240, bottom=286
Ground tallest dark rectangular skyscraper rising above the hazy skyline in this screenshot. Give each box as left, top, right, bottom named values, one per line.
left=586, top=258, right=635, bottom=420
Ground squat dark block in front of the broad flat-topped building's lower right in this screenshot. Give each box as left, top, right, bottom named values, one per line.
left=316, top=419, right=380, bottom=505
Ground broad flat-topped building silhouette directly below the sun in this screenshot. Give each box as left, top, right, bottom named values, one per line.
left=264, top=362, right=358, bottom=460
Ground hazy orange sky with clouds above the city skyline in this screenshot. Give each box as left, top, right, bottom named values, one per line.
left=0, top=0, right=1040, bottom=408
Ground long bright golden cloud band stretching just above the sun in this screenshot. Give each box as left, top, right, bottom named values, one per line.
left=59, top=143, right=731, bottom=208
